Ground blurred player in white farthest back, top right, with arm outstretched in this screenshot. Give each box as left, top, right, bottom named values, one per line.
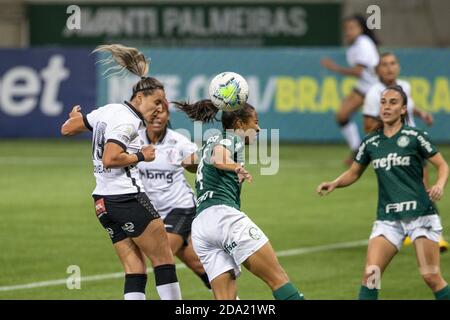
left=322, top=15, right=378, bottom=165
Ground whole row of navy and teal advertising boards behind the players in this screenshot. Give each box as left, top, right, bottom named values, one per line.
left=0, top=48, right=450, bottom=143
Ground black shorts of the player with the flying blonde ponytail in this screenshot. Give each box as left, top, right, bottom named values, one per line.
left=92, top=193, right=160, bottom=243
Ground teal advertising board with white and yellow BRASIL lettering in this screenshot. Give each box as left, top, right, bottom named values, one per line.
left=97, top=48, right=450, bottom=142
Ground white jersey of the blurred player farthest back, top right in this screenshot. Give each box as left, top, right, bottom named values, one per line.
left=346, top=34, right=380, bottom=94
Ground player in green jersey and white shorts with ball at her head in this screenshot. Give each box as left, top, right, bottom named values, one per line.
left=176, top=100, right=303, bottom=300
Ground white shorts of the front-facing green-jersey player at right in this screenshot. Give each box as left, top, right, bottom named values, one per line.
left=370, top=214, right=442, bottom=250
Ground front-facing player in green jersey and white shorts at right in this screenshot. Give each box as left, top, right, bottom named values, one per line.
left=317, top=86, right=450, bottom=299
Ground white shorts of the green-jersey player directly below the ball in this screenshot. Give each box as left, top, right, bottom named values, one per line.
left=191, top=205, right=269, bottom=281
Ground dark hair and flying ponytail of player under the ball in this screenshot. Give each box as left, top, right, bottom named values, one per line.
left=173, top=99, right=255, bottom=130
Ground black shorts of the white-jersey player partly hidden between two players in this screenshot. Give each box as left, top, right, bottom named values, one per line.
left=164, top=207, right=195, bottom=246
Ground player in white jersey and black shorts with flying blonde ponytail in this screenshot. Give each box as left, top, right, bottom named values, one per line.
left=61, top=44, right=181, bottom=300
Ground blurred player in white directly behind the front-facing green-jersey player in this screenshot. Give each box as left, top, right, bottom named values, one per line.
left=362, top=52, right=449, bottom=252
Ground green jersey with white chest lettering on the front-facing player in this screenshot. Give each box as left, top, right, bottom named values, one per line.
left=355, top=125, right=438, bottom=220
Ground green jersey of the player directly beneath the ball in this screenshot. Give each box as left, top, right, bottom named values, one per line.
left=195, top=132, right=244, bottom=215
